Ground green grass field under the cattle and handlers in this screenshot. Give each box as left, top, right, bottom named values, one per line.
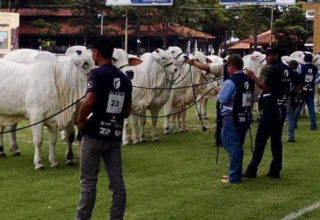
left=0, top=100, right=320, bottom=220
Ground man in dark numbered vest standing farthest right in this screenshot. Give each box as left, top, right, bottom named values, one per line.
left=294, top=53, right=318, bottom=130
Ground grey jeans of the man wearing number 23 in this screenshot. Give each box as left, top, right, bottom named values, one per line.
left=75, top=135, right=126, bottom=220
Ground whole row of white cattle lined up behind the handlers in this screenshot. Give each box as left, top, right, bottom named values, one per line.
left=0, top=46, right=320, bottom=169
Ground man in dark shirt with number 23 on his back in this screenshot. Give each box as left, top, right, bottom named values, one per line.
left=75, top=36, right=132, bottom=220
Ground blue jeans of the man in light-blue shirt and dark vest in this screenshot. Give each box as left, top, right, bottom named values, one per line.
left=221, top=116, right=249, bottom=183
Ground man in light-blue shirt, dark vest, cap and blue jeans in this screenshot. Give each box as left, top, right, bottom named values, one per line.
left=216, top=55, right=254, bottom=183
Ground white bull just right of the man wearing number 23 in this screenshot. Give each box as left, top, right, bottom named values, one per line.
left=122, top=49, right=177, bottom=145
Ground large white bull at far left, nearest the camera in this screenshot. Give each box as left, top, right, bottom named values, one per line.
left=0, top=48, right=94, bottom=169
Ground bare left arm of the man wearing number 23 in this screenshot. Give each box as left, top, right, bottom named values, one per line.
left=77, top=92, right=96, bottom=133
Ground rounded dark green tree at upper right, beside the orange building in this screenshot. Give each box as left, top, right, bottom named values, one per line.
left=274, top=5, right=312, bottom=53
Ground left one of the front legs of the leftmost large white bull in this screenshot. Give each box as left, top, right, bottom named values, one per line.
left=30, top=124, right=43, bottom=170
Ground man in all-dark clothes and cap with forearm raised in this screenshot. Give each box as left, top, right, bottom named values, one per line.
left=243, top=47, right=299, bottom=178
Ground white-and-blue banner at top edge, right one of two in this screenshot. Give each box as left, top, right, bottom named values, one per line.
left=220, top=0, right=296, bottom=5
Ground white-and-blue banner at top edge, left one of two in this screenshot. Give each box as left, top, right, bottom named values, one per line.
left=106, top=0, right=173, bottom=6
